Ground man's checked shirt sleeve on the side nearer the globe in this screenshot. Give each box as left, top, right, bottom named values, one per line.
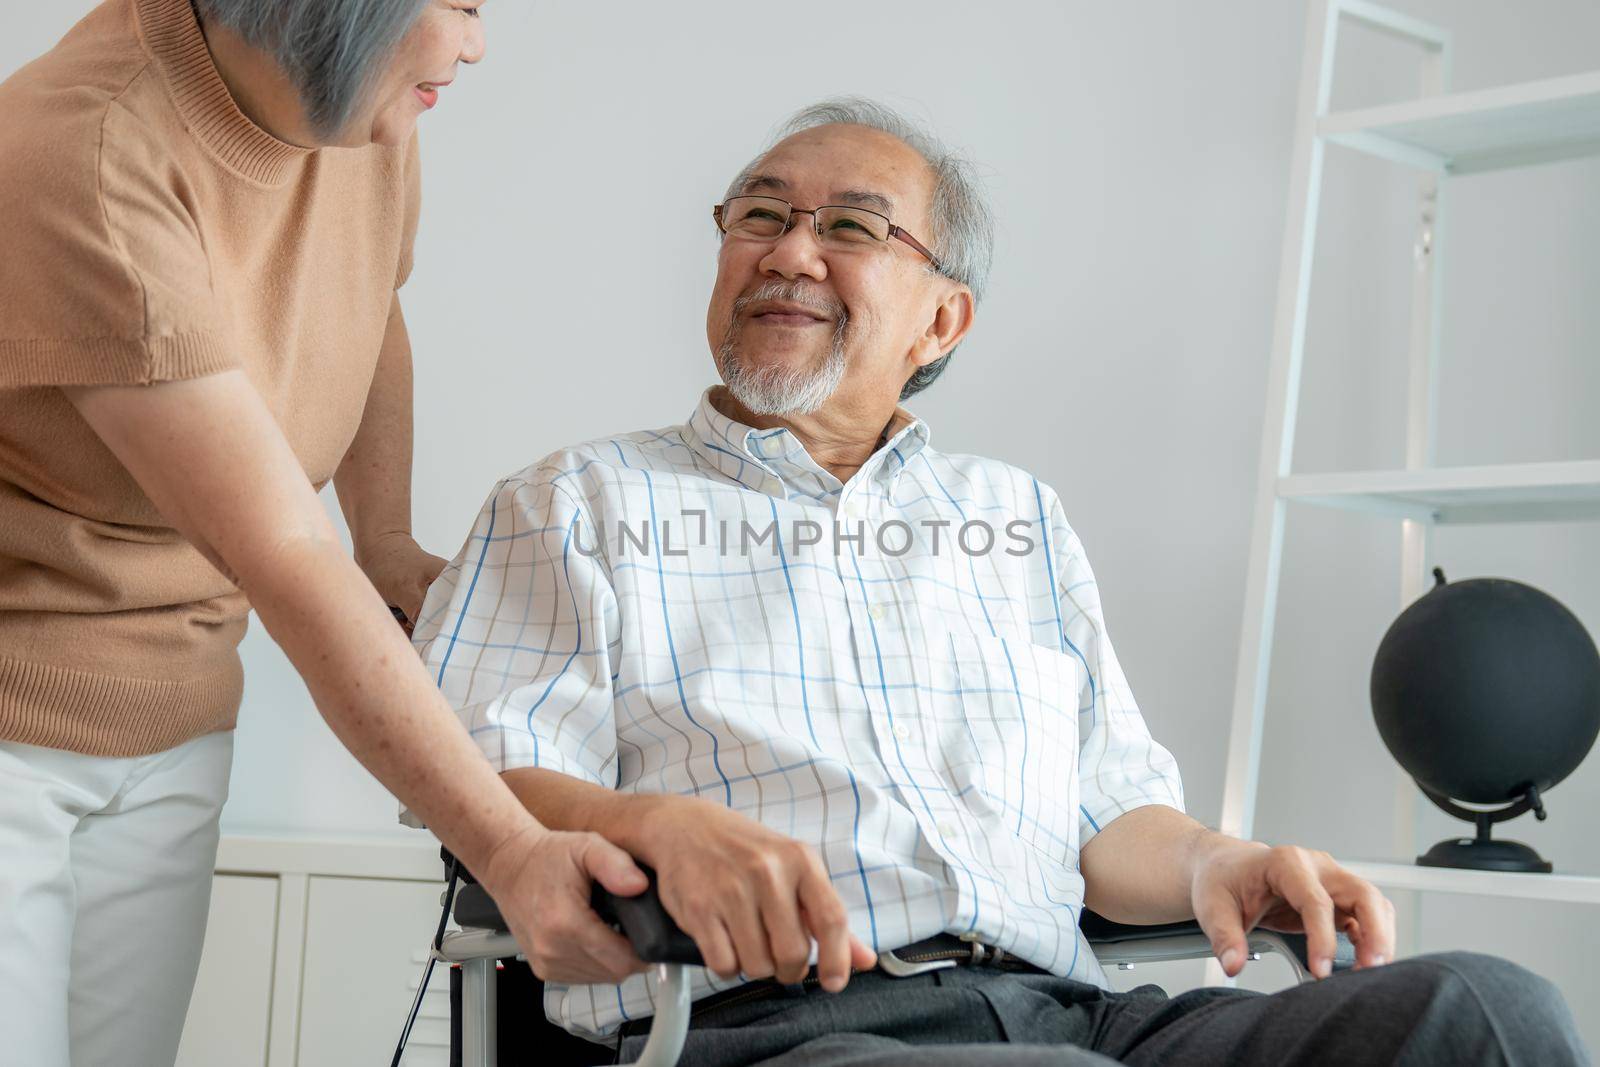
left=1050, top=494, right=1184, bottom=848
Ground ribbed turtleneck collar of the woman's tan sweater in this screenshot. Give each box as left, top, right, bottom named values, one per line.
left=134, top=0, right=315, bottom=186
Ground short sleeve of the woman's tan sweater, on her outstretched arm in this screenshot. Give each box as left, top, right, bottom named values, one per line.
left=0, top=101, right=235, bottom=387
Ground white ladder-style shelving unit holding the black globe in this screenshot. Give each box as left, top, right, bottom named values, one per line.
left=1213, top=0, right=1600, bottom=959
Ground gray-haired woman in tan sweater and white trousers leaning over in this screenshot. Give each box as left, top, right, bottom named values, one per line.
left=0, top=0, right=645, bottom=1067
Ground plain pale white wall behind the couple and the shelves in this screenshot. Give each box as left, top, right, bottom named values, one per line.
left=0, top=0, right=1600, bottom=1043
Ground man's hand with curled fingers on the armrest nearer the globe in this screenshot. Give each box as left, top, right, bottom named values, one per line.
left=1190, top=833, right=1395, bottom=977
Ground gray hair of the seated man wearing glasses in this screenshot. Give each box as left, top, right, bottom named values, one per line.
left=728, top=96, right=995, bottom=400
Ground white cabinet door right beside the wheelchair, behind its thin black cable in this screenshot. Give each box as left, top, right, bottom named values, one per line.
left=296, top=878, right=450, bottom=1067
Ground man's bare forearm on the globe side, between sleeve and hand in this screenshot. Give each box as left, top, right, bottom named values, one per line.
left=1078, top=805, right=1266, bottom=925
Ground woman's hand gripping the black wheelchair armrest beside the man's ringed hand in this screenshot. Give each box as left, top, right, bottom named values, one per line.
left=474, top=827, right=650, bottom=982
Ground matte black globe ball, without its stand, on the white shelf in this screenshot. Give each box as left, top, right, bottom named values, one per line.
left=1371, top=571, right=1600, bottom=806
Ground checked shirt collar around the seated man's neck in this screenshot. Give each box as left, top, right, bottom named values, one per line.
left=683, top=386, right=931, bottom=498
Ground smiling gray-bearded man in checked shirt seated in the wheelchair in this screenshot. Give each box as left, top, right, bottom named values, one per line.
left=418, top=101, right=1582, bottom=1067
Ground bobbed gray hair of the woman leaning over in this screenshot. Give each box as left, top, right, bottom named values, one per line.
left=195, top=0, right=427, bottom=136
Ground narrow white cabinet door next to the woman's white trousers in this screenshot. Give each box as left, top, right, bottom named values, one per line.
left=178, top=875, right=278, bottom=1067
